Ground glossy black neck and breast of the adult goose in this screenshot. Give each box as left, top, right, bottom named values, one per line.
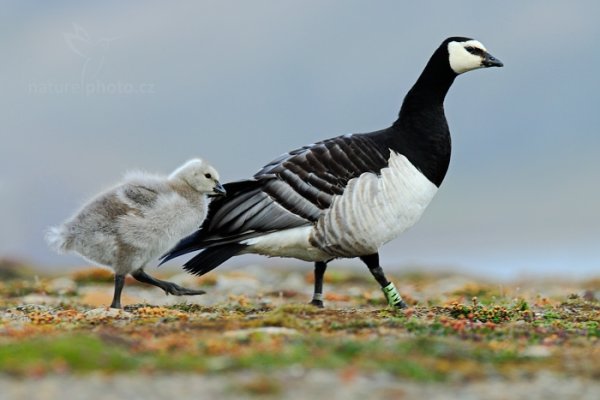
left=388, top=46, right=456, bottom=186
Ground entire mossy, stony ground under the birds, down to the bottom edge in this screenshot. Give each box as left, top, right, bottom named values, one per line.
left=0, top=260, right=600, bottom=399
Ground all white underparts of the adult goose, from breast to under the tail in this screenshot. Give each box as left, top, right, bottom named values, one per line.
left=242, top=151, right=437, bottom=261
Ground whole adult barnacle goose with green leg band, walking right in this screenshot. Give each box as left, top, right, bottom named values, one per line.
left=162, top=37, right=503, bottom=308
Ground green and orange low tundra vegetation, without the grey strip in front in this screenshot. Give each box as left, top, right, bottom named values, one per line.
left=0, top=260, right=600, bottom=392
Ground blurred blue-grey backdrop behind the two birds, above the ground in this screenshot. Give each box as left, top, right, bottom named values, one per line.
left=0, top=0, right=600, bottom=279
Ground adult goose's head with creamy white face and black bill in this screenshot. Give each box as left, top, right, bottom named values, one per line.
left=442, top=37, right=504, bottom=75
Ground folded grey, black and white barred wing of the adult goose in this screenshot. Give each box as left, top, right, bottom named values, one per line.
left=200, top=134, right=389, bottom=245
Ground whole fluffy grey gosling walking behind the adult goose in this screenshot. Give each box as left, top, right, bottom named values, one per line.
left=46, top=159, right=225, bottom=308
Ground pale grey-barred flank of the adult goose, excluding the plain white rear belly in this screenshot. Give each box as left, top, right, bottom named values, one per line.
left=311, top=151, right=437, bottom=257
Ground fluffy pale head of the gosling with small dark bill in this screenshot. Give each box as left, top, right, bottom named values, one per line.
left=169, top=158, right=225, bottom=196
